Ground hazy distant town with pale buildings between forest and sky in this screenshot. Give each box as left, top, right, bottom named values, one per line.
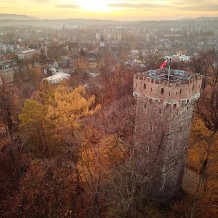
left=0, top=15, right=218, bottom=83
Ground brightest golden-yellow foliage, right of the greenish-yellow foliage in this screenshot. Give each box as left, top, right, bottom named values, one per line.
left=46, top=86, right=100, bottom=129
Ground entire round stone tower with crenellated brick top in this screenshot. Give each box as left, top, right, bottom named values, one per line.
left=133, top=69, right=202, bottom=201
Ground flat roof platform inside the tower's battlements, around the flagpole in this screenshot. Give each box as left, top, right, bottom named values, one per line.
left=137, top=68, right=199, bottom=83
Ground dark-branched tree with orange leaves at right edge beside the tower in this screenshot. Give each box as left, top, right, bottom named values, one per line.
left=191, top=51, right=218, bottom=217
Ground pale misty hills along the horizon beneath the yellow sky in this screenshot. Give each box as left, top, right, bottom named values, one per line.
left=0, top=14, right=218, bottom=28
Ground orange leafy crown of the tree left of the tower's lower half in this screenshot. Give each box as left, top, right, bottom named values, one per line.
left=77, top=135, right=127, bottom=182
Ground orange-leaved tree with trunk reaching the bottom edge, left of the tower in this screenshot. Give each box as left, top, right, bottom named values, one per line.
left=76, top=122, right=126, bottom=217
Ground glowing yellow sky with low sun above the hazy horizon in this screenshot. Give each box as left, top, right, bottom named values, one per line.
left=0, top=0, right=218, bottom=20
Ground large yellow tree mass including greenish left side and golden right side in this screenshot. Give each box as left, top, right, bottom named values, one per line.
left=19, top=86, right=100, bottom=157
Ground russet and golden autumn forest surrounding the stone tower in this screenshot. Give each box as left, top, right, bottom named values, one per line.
left=0, top=51, right=218, bottom=218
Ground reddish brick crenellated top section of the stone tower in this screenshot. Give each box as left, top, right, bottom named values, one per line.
left=133, top=69, right=202, bottom=104
